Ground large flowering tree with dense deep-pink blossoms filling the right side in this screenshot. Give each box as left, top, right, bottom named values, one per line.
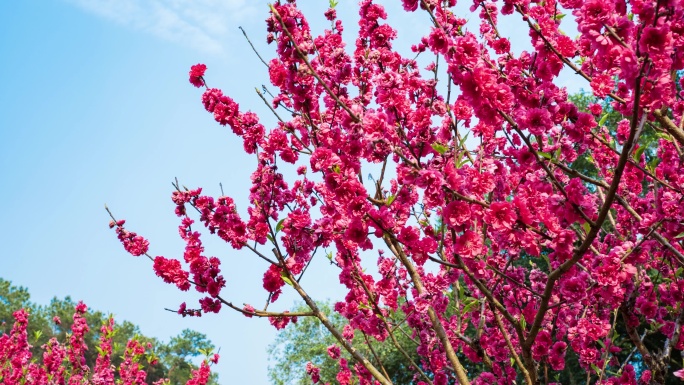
left=110, top=0, right=684, bottom=385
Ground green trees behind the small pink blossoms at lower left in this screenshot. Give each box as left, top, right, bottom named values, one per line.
left=0, top=278, right=218, bottom=385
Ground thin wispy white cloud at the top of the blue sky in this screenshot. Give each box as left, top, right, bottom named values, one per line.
left=67, top=0, right=260, bottom=54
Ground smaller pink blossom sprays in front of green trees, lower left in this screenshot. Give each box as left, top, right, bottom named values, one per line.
left=0, top=302, right=219, bottom=385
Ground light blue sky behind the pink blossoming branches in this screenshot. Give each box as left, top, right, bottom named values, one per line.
left=0, top=0, right=586, bottom=384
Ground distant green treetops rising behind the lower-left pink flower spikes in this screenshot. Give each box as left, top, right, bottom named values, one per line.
left=0, top=278, right=218, bottom=385
